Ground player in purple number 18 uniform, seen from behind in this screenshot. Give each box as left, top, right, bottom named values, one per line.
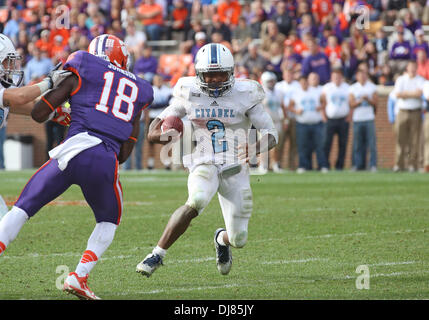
left=0, top=34, right=153, bottom=300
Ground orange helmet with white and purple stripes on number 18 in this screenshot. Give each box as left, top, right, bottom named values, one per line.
left=88, top=34, right=130, bottom=70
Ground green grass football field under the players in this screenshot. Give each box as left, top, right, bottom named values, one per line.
left=0, top=171, right=429, bottom=300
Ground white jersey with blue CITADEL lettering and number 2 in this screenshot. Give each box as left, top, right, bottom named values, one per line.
left=158, top=77, right=278, bottom=171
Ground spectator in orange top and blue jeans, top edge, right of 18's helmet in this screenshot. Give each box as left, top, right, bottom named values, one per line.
left=138, top=0, right=164, bottom=40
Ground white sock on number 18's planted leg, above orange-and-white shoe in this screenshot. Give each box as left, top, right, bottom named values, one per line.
left=75, top=222, right=118, bottom=277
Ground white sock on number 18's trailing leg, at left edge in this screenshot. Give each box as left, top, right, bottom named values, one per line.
left=0, top=206, right=29, bottom=254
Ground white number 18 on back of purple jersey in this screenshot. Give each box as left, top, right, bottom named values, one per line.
left=95, top=71, right=139, bottom=122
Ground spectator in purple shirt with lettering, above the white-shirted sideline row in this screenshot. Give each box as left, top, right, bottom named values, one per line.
left=302, top=38, right=331, bottom=85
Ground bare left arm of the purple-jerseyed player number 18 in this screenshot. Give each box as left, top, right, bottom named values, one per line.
left=31, top=74, right=79, bottom=123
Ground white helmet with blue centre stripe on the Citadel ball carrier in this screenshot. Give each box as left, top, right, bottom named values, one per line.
left=195, top=43, right=234, bottom=98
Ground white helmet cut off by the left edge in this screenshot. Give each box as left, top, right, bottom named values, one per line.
left=0, top=33, right=24, bottom=88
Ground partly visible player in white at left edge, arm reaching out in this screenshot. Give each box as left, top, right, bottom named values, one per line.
left=0, top=33, right=71, bottom=128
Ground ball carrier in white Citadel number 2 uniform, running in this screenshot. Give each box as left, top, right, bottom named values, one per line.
left=136, top=43, right=278, bottom=277
